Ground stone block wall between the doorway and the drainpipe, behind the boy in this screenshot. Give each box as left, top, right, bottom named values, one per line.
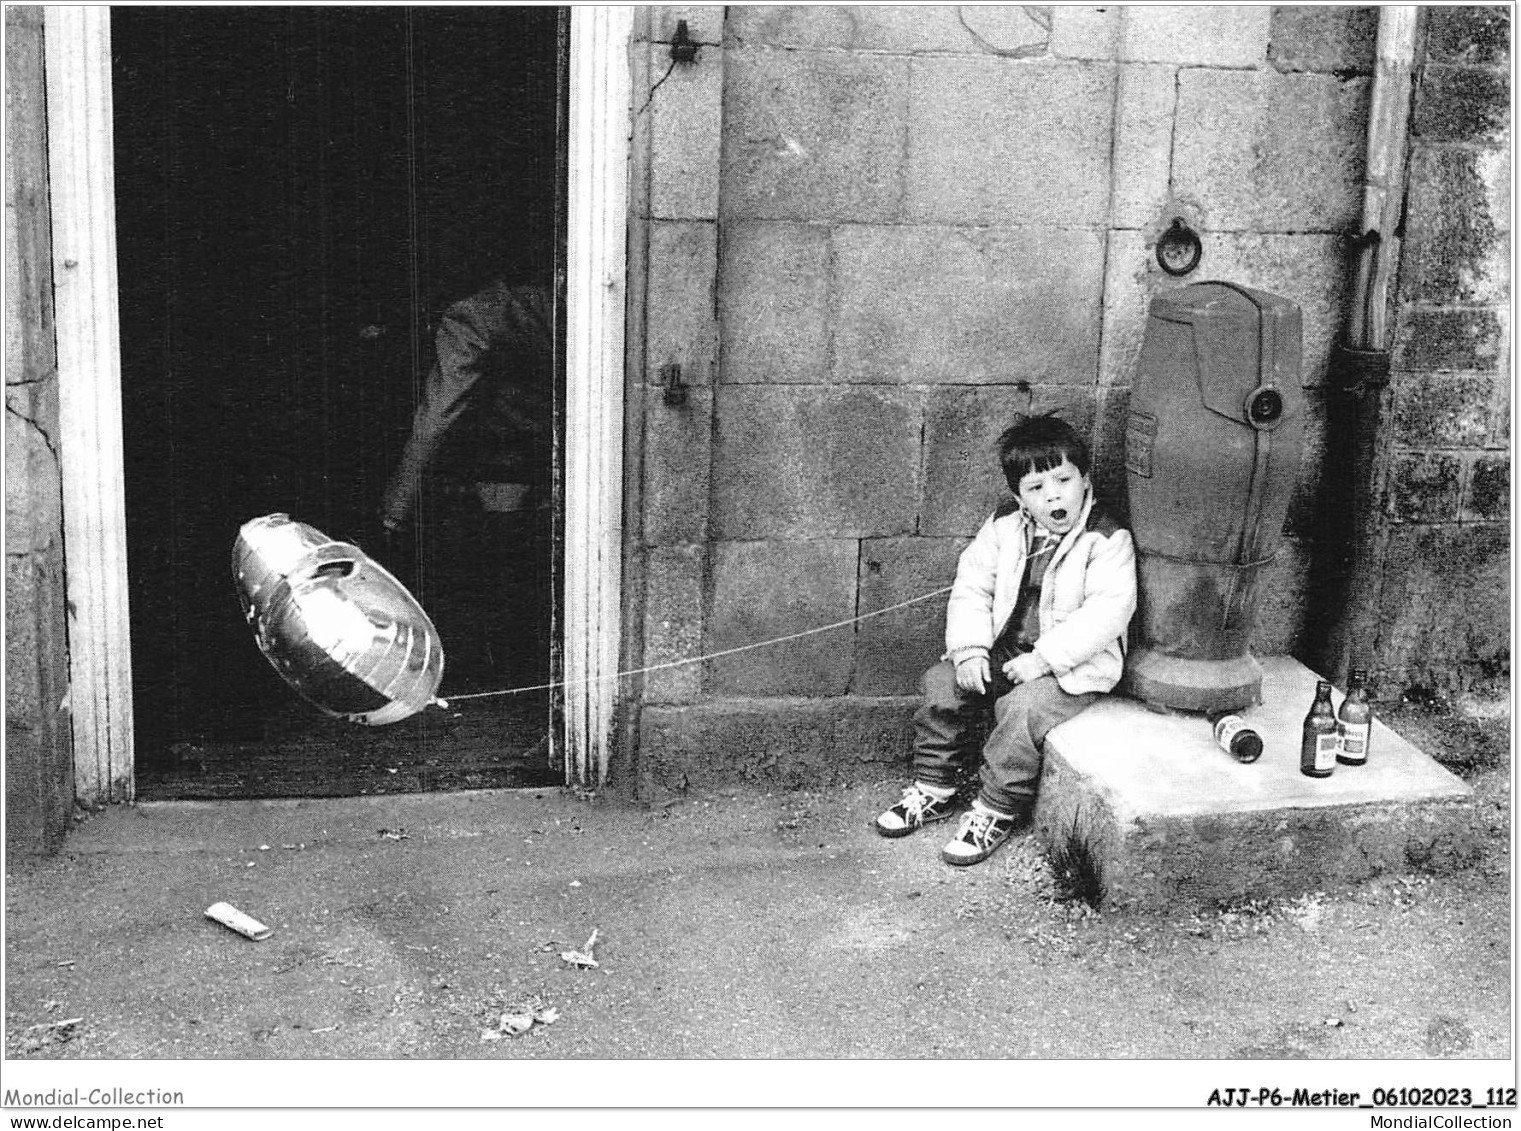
left=630, top=5, right=1411, bottom=786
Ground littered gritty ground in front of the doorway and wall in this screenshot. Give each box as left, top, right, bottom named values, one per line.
left=5, top=699, right=1512, bottom=1106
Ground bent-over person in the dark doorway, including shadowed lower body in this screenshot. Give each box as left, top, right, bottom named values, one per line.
left=379, top=280, right=555, bottom=693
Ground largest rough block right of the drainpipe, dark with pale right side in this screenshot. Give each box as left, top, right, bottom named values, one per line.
left=1404, top=146, right=1510, bottom=304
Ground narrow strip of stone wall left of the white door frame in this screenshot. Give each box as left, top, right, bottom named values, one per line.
left=5, top=8, right=75, bottom=851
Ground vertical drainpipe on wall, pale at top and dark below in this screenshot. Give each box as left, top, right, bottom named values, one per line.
left=1326, top=5, right=1419, bottom=687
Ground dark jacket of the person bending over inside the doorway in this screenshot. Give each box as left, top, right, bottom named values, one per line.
left=380, top=280, right=554, bottom=532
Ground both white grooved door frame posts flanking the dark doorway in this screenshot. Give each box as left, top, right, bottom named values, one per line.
left=43, top=6, right=634, bottom=806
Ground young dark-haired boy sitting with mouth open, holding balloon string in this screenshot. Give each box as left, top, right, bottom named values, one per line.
left=876, top=415, right=1136, bottom=865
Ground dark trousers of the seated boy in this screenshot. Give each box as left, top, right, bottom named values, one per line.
left=914, top=660, right=1100, bottom=813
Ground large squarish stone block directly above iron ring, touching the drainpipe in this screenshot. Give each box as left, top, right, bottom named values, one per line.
left=1173, top=70, right=1369, bottom=233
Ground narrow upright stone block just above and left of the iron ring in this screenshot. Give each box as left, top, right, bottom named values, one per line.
left=1110, top=65, right=1177, bottom=228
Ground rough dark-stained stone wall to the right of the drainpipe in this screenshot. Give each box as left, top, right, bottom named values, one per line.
left=1372, top=6, right=1510, bottom=698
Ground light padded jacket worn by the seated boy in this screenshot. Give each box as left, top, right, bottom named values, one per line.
left=945, top=491, right=1136, bottom=695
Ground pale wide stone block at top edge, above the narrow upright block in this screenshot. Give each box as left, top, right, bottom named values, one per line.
left=1119, top=5, right=1273, bottom=67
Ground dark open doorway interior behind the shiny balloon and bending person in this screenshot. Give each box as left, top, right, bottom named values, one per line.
left=113, top=6, right=564, bottom=798
